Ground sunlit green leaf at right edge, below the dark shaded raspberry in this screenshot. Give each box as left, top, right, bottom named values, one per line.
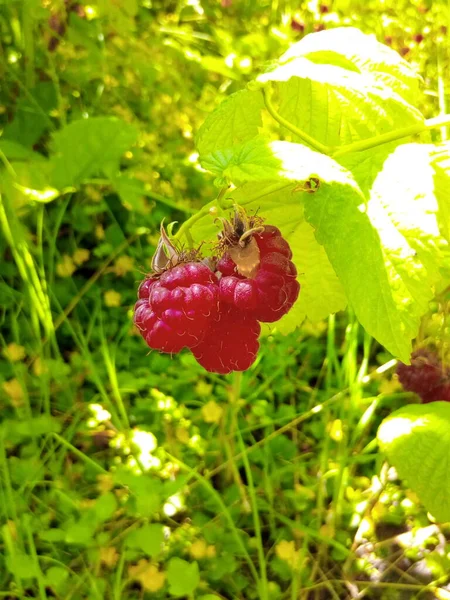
left=378, top=402, right=450, bottom=522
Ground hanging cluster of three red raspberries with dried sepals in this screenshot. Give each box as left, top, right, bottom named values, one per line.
left=134, top=213, right=300, bottom=374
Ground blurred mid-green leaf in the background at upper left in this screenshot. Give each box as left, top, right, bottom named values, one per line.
left=52, top=117, right=138, bottom=189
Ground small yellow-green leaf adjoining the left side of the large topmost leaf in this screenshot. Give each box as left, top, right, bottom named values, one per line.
left=196, top=90, right=264, bottom=156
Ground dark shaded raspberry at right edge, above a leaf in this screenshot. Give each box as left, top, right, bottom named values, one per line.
left=397, top=348, right=450, bottom=402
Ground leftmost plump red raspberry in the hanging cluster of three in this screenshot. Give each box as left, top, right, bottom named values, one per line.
left=134, top=262, right=219, bottom=353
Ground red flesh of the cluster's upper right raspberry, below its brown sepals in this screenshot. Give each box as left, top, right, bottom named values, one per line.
left=217, top=225, right=300, bottom=323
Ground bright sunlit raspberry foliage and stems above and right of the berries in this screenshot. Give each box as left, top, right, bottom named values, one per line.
left=174, top=28, right=450, bottom=520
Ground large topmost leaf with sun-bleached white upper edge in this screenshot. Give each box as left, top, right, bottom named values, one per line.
left=254, top=28, right=424, bottom=146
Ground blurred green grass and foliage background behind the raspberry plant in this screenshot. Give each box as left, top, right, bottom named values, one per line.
left=0, top=0, right=450, bottom=600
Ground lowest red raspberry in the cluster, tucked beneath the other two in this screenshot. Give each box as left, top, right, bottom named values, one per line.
left=192, top=305, right=261, bottom=374
